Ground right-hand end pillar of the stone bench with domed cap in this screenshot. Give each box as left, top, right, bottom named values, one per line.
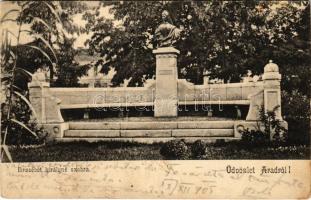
left=262, top=60, right=282, bottom=120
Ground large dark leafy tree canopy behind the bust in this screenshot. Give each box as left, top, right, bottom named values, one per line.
left=84, top=0, right=309, bottom=86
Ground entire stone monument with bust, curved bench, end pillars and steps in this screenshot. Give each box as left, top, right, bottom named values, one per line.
left=28, top=11, right=287, bottom=142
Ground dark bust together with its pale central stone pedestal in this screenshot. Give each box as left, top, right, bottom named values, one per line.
left=153, top=10, right=181, bottom=117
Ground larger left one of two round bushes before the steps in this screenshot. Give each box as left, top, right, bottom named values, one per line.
left=160, top=140, right=189, bottom=159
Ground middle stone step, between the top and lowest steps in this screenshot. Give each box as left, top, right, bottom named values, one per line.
left=64, top=129, right=234, bottom=138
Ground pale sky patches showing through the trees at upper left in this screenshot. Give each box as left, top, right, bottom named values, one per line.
left=0, top=1, right=113, bottom=48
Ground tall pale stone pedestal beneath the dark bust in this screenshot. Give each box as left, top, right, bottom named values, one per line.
left=153, top=47, right=179, bottom=117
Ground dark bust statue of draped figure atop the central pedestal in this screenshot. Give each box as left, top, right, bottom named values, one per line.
left=155, top=10, right=181, bottom=47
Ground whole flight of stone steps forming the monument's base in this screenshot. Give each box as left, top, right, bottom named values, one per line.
left=43, top=118, right=287, bottom=143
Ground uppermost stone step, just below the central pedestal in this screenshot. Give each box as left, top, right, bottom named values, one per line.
left=69, top=121, right=234, bottom=130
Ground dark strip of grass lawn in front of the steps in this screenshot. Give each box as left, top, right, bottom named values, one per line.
left=4, top=142, right=310, bottom=162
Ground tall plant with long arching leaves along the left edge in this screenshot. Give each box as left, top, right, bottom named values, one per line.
left=0, top=2, right=64, bottom=162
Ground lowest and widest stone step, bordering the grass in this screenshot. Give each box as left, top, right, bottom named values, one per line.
left=55, top=137, right=239, bottom=144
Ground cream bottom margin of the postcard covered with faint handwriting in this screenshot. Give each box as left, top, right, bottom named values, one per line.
left=2, top=161, right=310, bottom=198
